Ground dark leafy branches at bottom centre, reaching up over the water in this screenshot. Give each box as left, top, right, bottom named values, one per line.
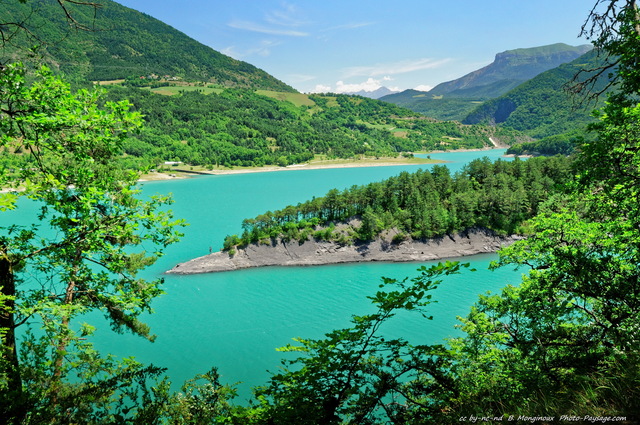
left=250, top=262, right=469, bottom=424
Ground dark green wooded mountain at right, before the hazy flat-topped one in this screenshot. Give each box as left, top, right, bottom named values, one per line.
left=463, top=50, right=609, bottom=138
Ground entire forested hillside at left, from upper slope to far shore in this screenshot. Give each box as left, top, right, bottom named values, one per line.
left=0, top=0, right=526, bottom=176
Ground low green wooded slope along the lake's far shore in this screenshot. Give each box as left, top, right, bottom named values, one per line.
left=102, top=87, right=526, bottom=167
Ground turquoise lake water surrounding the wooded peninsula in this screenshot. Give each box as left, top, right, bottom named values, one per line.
left=7, top=150, right=520, bottom=398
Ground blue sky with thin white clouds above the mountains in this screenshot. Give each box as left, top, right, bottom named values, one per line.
left=119, top=0, right=595, bottom=92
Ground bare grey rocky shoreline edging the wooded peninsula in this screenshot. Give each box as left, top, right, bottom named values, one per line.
left=167, top=228, right=522, bottom=275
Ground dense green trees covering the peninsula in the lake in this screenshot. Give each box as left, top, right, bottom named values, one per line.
left=224, top=156, right=572, bottom=250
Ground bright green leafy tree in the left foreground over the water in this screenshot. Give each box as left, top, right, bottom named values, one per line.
left=0, top=64, right=205, bottom=423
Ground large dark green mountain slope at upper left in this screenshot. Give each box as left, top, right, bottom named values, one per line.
left=0, top=0, right=295, bottom=92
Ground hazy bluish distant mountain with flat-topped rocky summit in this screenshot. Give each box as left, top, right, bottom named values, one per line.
left=380, top=43, right=592, bottom=121
